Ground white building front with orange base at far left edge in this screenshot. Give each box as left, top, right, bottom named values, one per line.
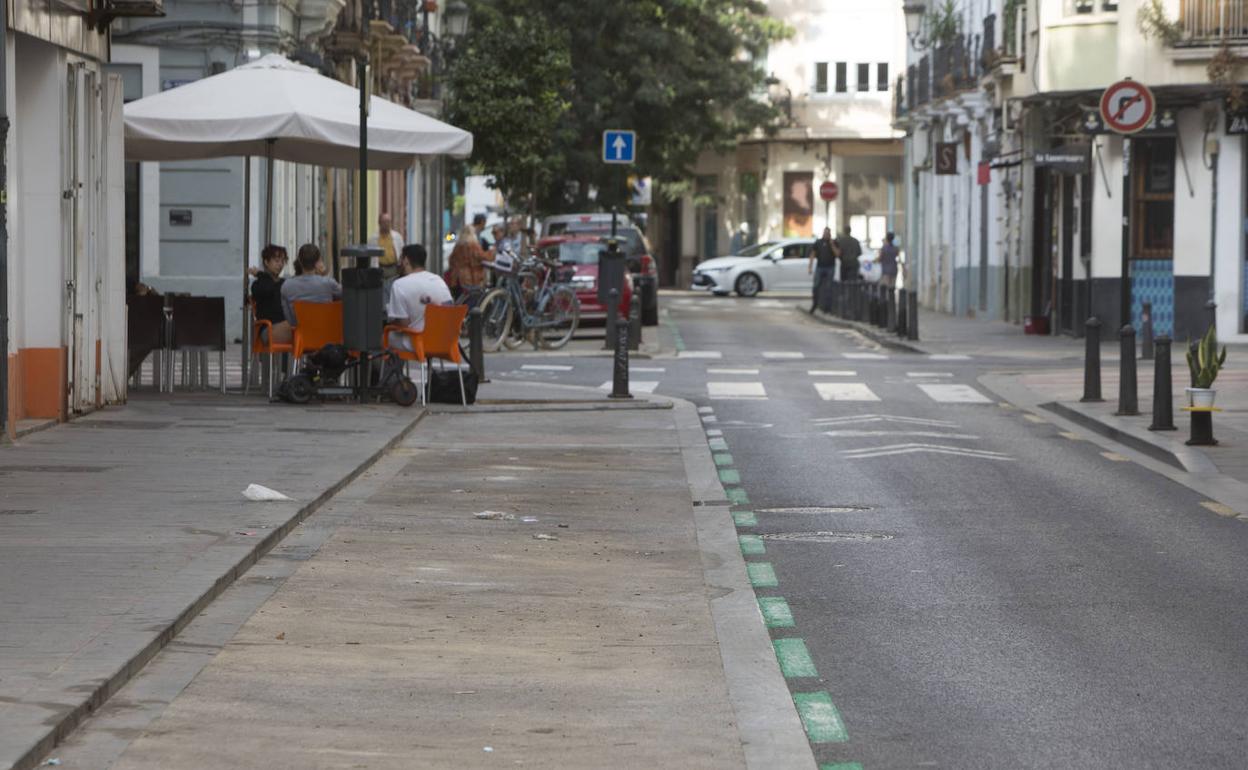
left=0, top=0, right=140, bottom=437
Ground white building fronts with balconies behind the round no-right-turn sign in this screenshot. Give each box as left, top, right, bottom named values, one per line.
left=896, top=0, right=1248, bottom=339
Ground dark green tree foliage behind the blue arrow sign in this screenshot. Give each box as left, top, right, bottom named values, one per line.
left=452, top=0, right=789, bottom=211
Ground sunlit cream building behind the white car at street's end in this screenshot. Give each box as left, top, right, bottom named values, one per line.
left=651, top=0, right=906, bottom=286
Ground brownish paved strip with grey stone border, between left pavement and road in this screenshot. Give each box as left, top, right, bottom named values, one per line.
left=39, top=383, right=814, bottom=770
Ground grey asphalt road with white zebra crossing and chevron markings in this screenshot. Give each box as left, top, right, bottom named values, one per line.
left=492, top=290, right=1248, bottom=769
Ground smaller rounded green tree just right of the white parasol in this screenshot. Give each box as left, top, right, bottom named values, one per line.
left=447, top=2, right=572, bottom=205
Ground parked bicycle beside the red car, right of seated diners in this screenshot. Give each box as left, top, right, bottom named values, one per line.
left=480, top=255, right=580, bottom=352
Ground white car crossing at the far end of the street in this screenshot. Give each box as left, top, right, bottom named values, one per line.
left=693, top=238, right=815, bottom=297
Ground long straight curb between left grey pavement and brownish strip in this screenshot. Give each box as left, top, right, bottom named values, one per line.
left=10, top=409, right=428, bottom=770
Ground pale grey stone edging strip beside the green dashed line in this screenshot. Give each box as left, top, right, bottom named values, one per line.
left=666, top=397, right=816, bottom=770
